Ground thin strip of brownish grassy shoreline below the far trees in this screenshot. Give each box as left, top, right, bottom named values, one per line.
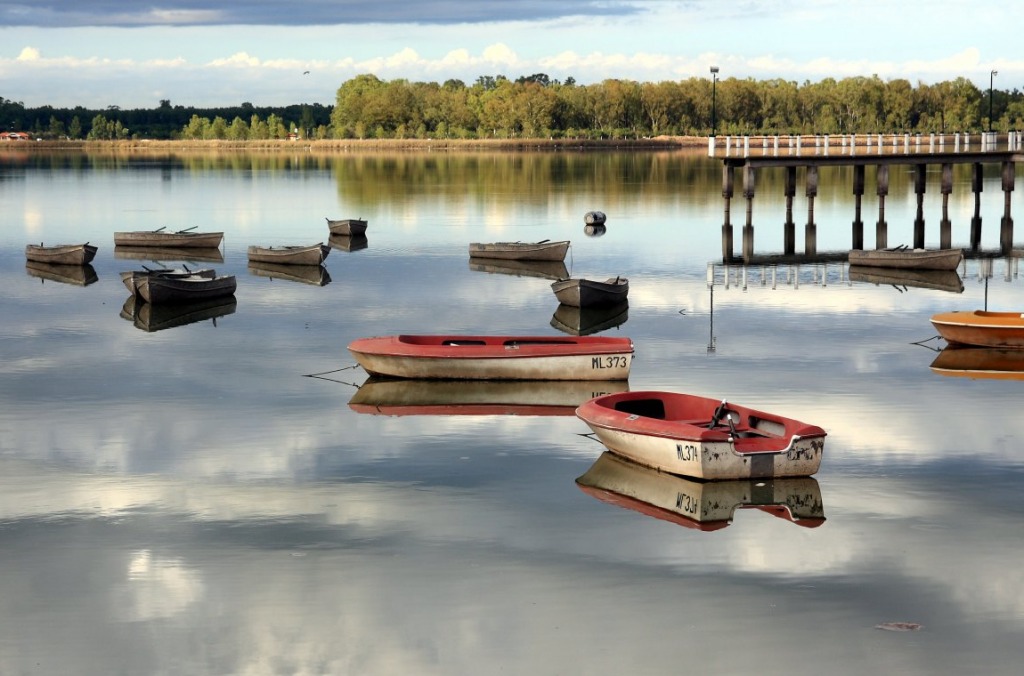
left=0, top=136, right=708, bottom=153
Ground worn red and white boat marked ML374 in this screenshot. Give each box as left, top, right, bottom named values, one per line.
left=577, top=391, right=825, bottom=480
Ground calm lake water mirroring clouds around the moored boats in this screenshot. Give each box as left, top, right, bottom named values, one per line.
left=0, top=152, right=1024, bottom=675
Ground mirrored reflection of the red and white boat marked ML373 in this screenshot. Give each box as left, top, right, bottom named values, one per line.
left=348, top=378, right=629, bottom=416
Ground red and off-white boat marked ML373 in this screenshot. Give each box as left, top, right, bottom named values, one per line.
left=348, top=335, right=633, bottom=380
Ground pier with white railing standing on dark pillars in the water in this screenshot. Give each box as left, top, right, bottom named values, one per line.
left=709, top=132, right=1024, bottom=262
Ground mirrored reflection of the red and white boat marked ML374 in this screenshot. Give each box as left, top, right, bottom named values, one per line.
left=575, top=451, right=825, bottom=531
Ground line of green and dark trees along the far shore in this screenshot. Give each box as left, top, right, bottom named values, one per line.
left=0, top=73, right=1024, bottom=140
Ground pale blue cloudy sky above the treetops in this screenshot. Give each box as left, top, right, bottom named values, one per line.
left=0, top=0, right=1024, bottom=108
